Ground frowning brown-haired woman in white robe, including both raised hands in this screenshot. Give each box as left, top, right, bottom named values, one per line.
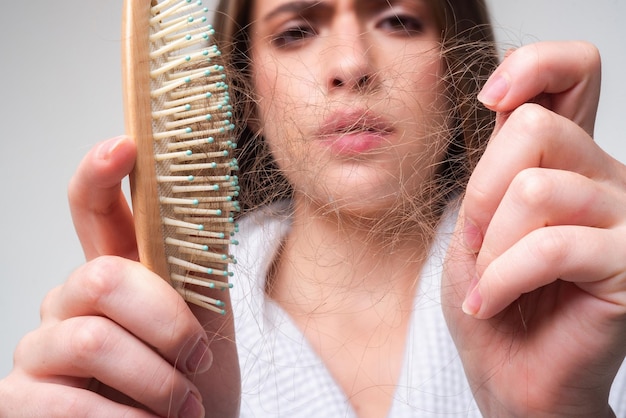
left=0, top=0, right=626, bottom=417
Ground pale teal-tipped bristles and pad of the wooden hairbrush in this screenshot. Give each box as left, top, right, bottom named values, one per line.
left=138, top=0, right=239, bottom=313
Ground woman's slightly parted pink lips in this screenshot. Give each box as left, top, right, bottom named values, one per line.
left=319, top=109, right=393, bottom=155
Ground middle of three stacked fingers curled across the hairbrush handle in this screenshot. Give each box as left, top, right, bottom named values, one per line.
left=18, top=317, right=202, bottom=416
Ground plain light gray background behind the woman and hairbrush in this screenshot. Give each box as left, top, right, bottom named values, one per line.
left=0, top=0, right=626, bottom=377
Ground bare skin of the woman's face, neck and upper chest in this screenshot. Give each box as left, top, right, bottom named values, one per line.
left=246, top=0, right=447, bottom=417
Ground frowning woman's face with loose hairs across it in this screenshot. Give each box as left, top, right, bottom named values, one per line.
left=250, top=0, right=447, bottom=216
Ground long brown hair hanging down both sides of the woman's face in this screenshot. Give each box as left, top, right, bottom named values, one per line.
left=213, top=0, right=498, bottom=219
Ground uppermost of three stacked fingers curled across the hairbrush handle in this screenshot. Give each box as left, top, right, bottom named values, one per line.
left=42, top=257, right=212, bottom=373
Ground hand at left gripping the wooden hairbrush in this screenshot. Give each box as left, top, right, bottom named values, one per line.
left=0, top=137, right=239, bottom=417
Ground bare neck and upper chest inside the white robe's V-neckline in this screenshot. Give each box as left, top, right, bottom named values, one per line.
left=267, top=193, right=444, bottom=417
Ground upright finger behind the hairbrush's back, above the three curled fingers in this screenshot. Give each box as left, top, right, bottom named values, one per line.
left=68, top=137, right=138, bottom=260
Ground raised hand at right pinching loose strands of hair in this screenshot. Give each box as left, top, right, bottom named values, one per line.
left=443, top=42, right=626, bottom=416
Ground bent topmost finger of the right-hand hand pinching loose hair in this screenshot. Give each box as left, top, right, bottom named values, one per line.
left=478, top=42, right=601, bottom=135
